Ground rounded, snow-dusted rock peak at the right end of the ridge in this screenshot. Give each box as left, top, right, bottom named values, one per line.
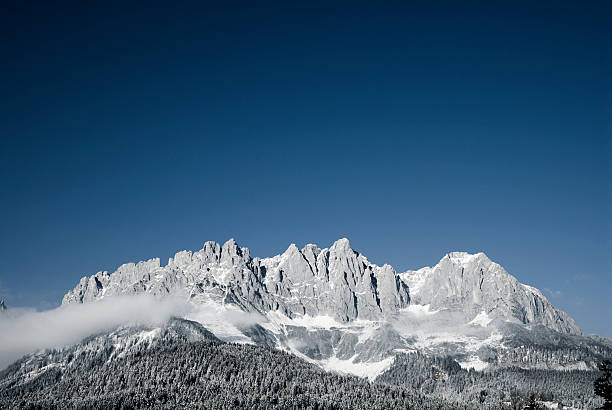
left=401, top=252, right=581, bottom=334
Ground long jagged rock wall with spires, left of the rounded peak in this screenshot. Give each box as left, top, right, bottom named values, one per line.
left=62, top=239, right=409, bottom=322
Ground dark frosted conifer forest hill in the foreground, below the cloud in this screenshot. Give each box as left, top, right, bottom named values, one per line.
left=0, top=332, right=482, bottom=409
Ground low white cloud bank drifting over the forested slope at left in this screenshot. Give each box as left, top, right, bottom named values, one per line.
left=0, top=295, right=190, bottom=369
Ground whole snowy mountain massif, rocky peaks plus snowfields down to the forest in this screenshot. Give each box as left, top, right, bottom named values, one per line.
left=62, top=239, right=595, bottom=378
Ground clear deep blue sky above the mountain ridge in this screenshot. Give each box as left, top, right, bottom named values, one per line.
left=0, top=1, right=612, bottom=337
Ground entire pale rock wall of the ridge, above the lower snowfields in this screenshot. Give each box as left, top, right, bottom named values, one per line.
left=62, top=239, right=580, bottom=334
